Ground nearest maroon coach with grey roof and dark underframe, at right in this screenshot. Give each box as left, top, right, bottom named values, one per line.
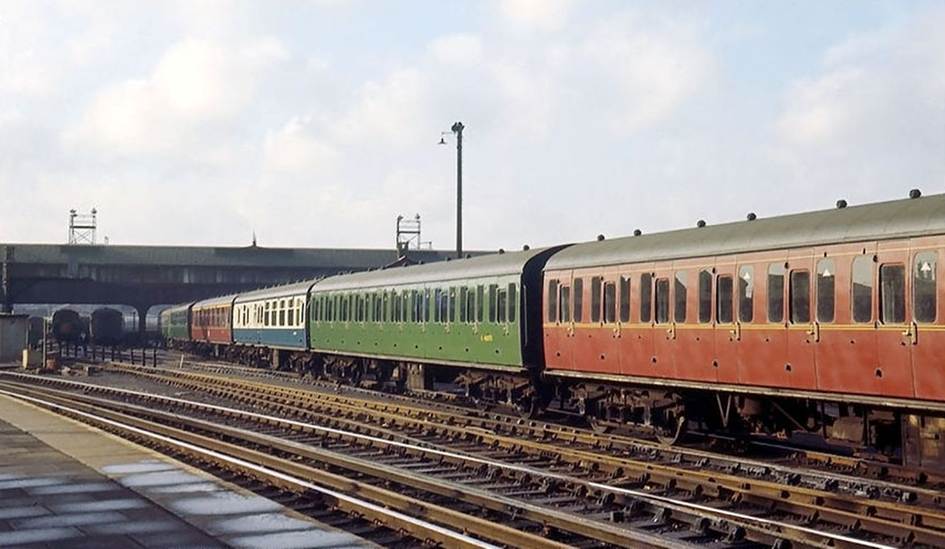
left=542, top=192, right=945, bottom=468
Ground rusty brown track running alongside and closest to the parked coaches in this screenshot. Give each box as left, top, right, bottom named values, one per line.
left=110, top=358, right=945, bottom=511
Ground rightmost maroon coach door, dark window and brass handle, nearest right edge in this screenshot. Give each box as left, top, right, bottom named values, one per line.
left=870, top=242, right=918, bottom=397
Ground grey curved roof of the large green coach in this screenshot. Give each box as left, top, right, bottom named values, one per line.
left=314, top=248, right=546, bottom=292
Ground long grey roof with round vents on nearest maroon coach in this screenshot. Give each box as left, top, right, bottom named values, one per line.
left=545, top=195, right=945, bottom=271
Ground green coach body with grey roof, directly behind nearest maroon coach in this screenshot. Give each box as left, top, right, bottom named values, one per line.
left=309, top=248, right=560, bottom=394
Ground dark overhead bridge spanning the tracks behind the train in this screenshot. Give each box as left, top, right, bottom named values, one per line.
left=0, top=243, right=472, bottom=331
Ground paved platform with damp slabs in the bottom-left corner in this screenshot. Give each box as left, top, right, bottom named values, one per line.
left=0, top=395, right=370, bottom=549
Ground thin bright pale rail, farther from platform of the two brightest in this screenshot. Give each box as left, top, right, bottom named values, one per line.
left=0, top=372, right=920, bottom=547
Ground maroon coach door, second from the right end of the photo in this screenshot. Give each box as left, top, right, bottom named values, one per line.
left=782, top=250, right=820, bottom=389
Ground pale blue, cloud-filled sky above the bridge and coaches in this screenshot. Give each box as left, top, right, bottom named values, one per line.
left=0, top=0, right=945, bottom=250
